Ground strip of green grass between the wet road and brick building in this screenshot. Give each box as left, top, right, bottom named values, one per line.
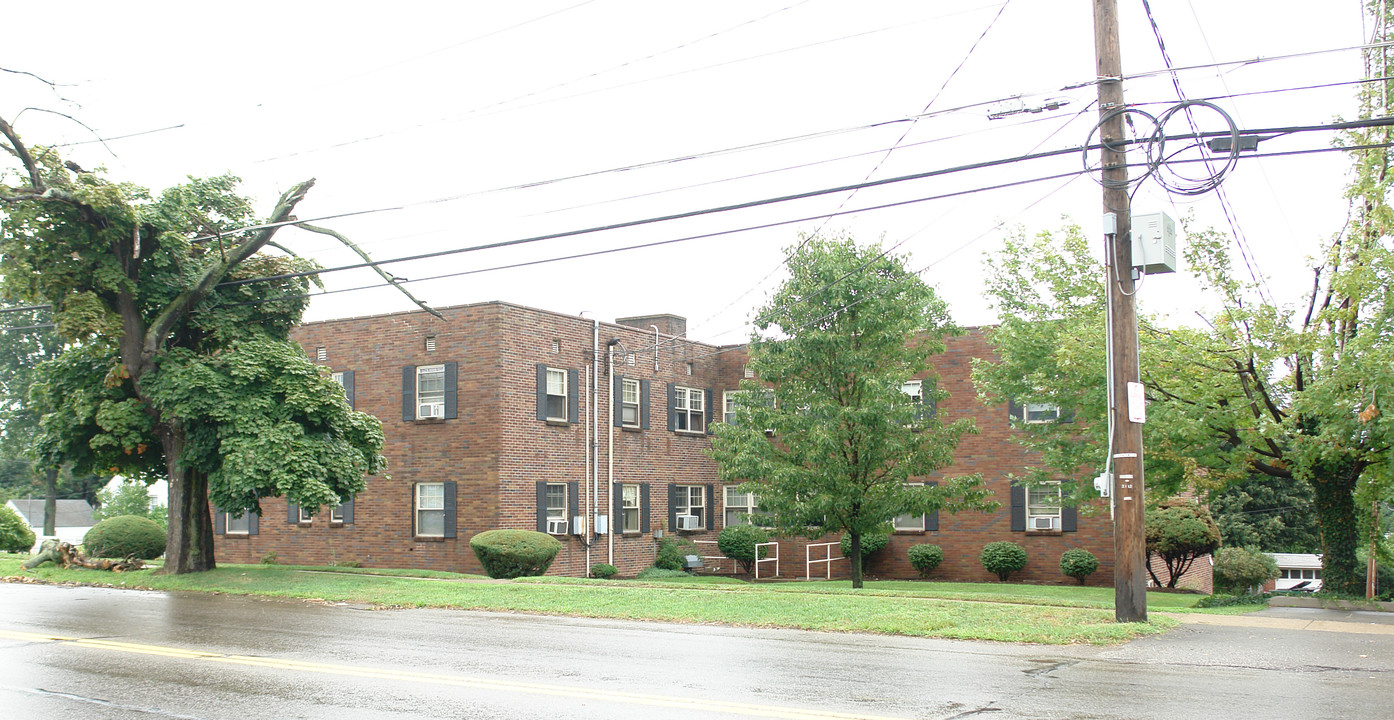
left=0, top=558, right=1177, bottom=645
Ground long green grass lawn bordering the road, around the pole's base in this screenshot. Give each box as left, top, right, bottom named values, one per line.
left=0, top=554, right=1199, bottom=645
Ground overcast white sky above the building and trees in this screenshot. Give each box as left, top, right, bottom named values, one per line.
left=0, top=0, right=1363, bottom=343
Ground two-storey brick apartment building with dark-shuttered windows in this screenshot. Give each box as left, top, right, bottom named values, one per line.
left=215, top=301, right=1112, bottom=585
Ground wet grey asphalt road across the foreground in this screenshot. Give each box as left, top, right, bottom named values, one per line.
left=0, top=585, right=1394, bottom=720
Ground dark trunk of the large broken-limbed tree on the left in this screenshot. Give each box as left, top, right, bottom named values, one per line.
left=156, top=426, right=217, bottom=575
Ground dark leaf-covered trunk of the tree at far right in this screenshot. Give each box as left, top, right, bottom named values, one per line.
left=1309, top=462, right=1365, bottom=596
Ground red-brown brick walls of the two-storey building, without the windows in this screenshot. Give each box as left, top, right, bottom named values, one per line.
left=217, top=303, right=1112, bottom=585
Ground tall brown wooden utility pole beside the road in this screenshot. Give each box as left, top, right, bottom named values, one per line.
left=1094, top=0, right=1147, bottom=622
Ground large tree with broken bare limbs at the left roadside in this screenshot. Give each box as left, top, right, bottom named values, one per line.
left=0, top=119, right=383, bottom=573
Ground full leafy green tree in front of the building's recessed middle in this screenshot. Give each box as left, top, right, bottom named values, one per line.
left=712, top=237, right=994, bottom=587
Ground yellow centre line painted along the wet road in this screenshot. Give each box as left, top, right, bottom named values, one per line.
left=0, top=629, right=894, bottom=720
